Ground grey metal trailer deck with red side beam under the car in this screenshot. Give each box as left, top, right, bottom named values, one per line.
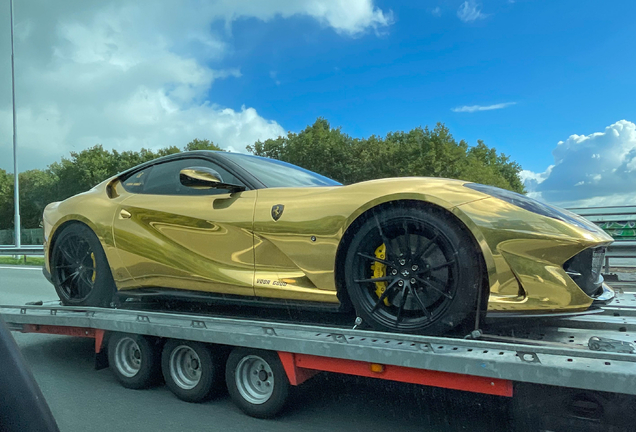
left=0, top=284, right=636, bottom=397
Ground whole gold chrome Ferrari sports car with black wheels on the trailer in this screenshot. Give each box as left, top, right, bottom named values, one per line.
left=44, top=151, right=613, bottom=334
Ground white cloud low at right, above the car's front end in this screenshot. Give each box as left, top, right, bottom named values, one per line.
left=521, top=120, right=636, bottom=207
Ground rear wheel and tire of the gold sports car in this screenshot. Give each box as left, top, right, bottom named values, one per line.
left=50, top=223, right=117, bottom=307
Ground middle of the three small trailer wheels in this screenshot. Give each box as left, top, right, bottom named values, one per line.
left=161, top=340, right=222, bottom=402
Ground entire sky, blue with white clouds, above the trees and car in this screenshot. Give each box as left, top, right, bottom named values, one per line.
left=0, top=0, right=636, bottom=204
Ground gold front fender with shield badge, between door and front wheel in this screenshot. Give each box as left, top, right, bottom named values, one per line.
left=254, top=178, right=484, bottom=303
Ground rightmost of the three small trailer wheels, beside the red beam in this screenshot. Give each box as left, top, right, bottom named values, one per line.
left=225, top=348, right=289, bottom=418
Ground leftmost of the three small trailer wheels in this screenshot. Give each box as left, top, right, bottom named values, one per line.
left=108, top=333, right=161, bottom=389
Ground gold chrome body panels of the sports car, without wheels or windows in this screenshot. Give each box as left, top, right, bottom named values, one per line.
left=44, top=152, right=612, bottom=313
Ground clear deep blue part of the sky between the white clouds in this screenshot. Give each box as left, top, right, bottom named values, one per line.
left=210, top=0, right=636, bottom=171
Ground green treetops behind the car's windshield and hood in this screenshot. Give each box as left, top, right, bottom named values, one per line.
left=247, top=118, right=523, bottom=192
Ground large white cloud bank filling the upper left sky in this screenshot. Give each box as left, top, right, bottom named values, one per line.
left=0, top=0, right=392, bottom=170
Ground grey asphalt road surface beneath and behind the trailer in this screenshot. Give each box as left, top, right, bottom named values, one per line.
left=0, top=266, right=510, bottom=432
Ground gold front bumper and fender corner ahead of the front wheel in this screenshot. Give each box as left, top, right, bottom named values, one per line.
left=456, top=198, right=612, bottom=312
